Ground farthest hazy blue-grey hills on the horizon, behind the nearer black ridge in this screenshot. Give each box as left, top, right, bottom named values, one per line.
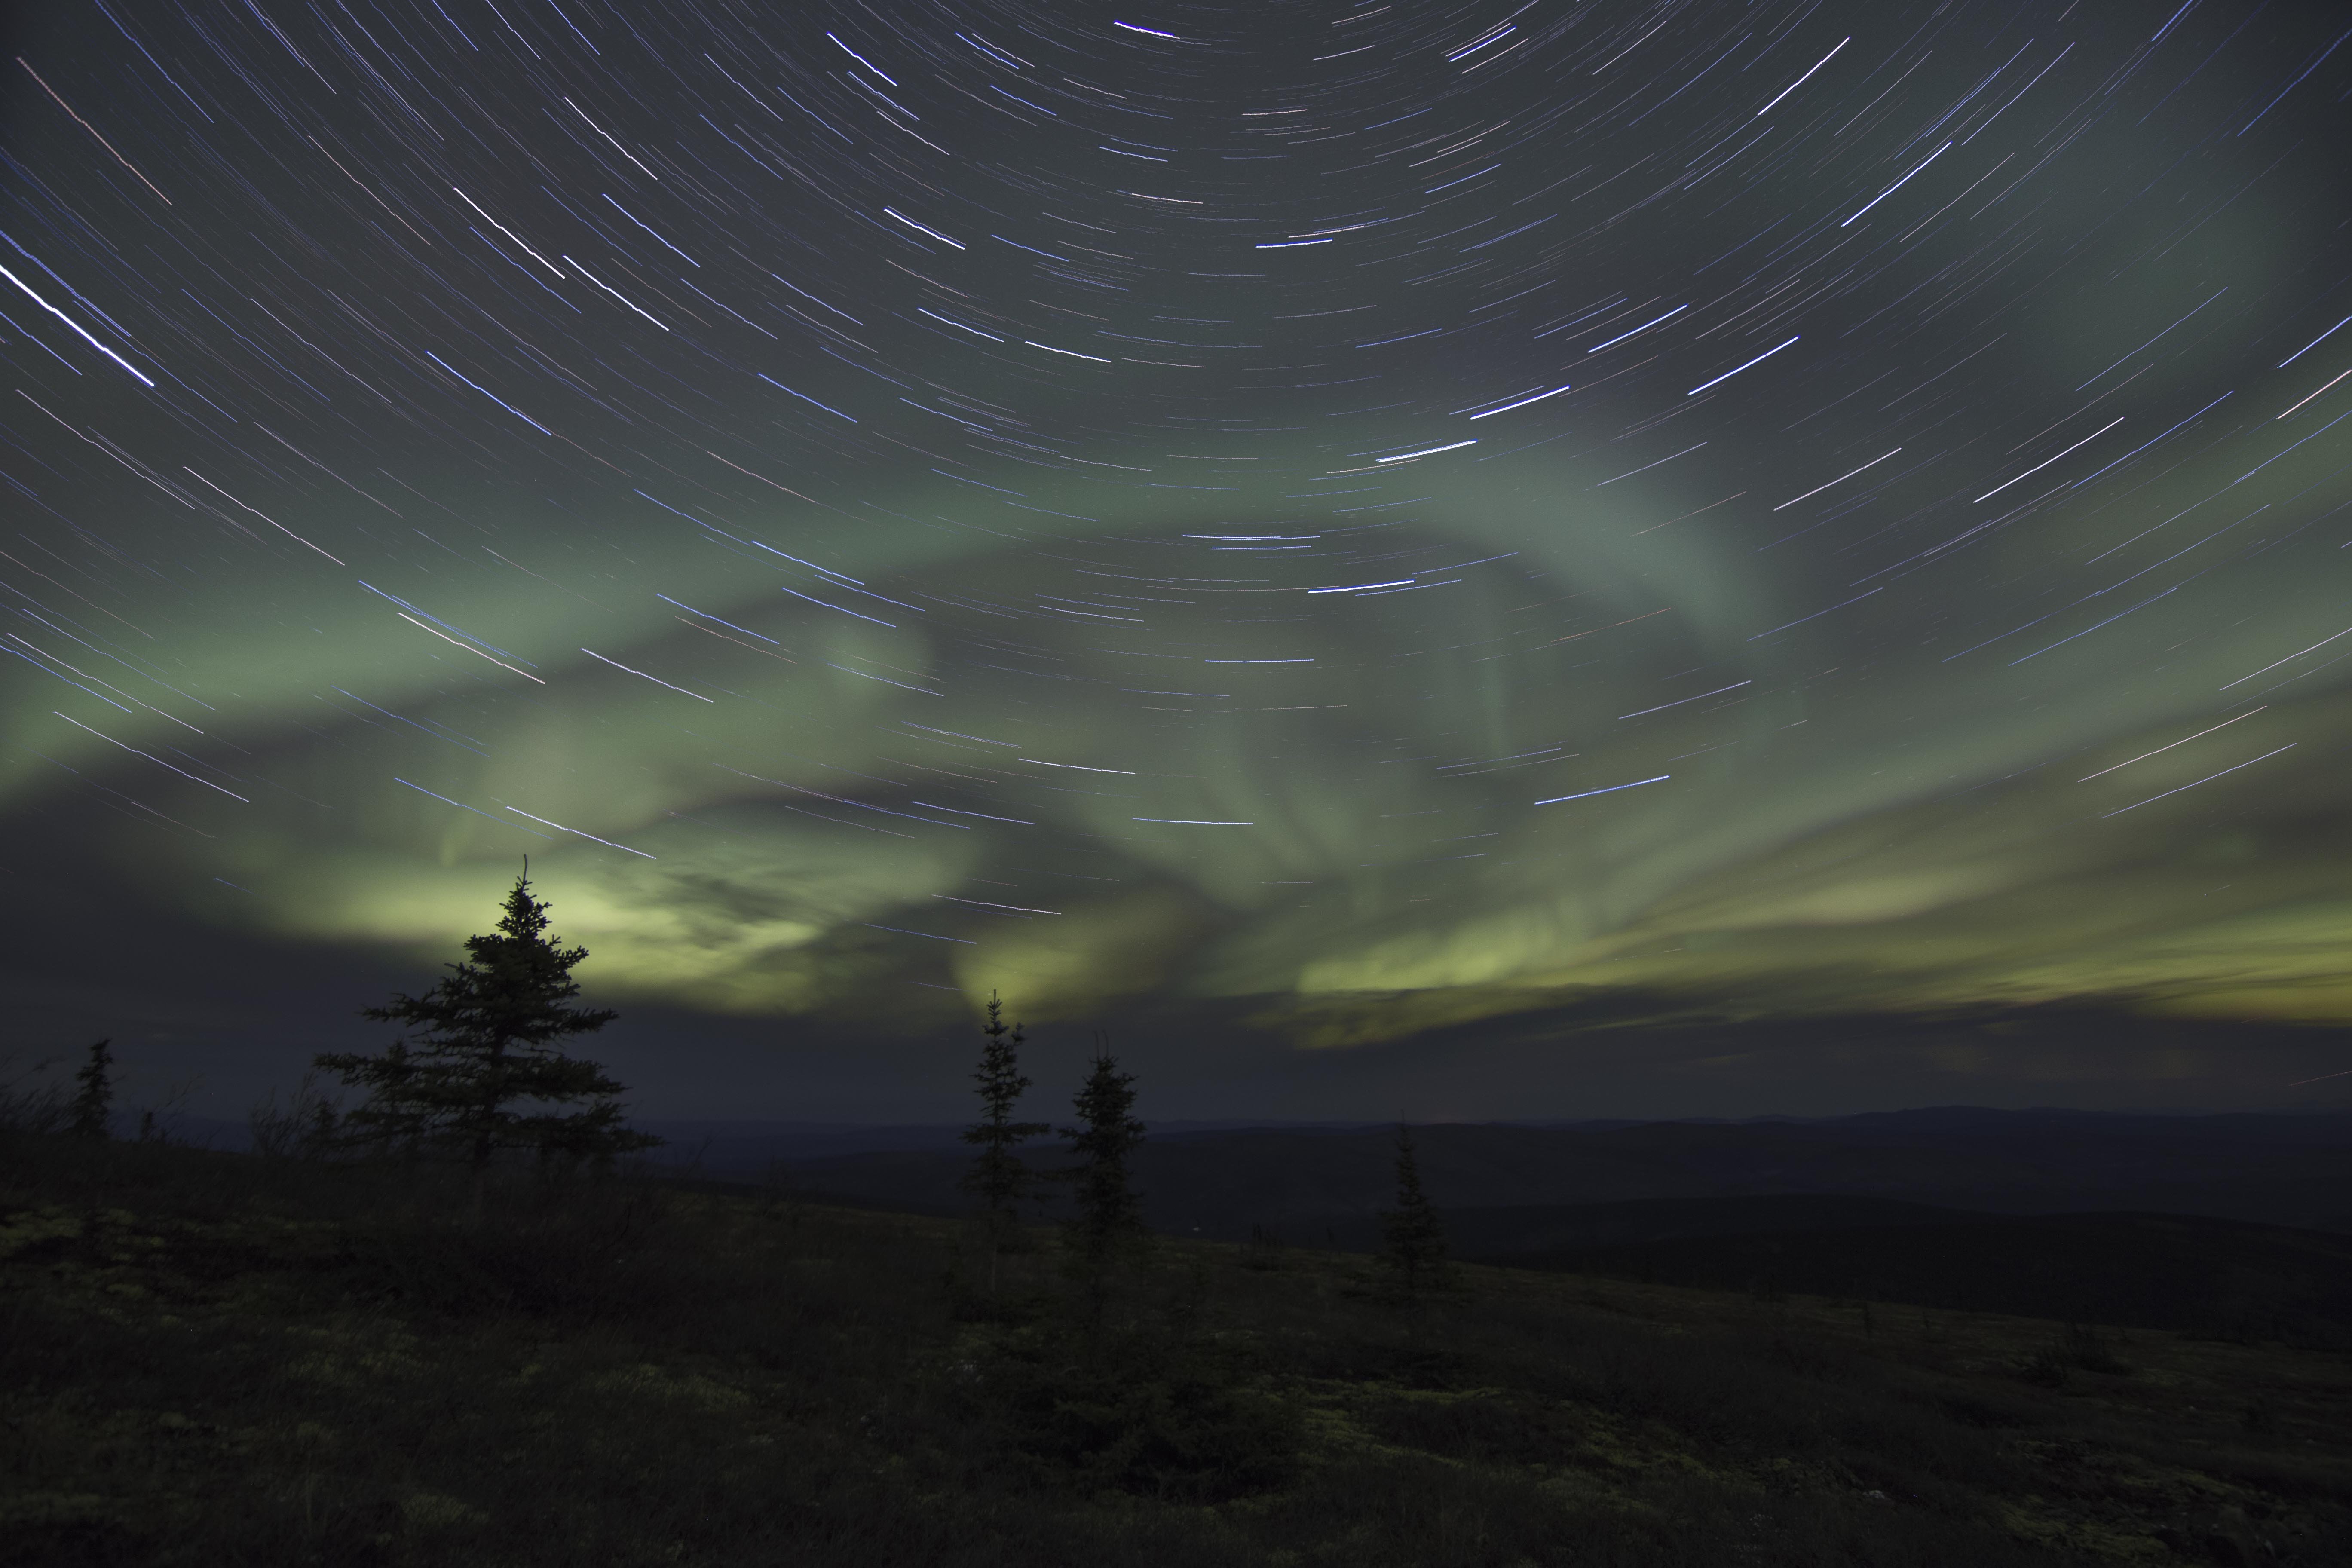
left=724, top=1107, right=2352, bottom=1241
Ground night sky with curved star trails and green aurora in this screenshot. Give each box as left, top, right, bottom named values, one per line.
left=0, top=0, right=2352, bottom=1117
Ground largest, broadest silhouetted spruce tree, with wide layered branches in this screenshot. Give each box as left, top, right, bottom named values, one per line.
left=318, top=867, right=661, bottom=1213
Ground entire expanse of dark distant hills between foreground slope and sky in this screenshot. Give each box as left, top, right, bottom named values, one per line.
left=142, top=1105, right=2352, bottom=1349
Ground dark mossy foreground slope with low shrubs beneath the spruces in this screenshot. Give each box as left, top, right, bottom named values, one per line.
left=0, top=1138, right=2352, bottom=1568
